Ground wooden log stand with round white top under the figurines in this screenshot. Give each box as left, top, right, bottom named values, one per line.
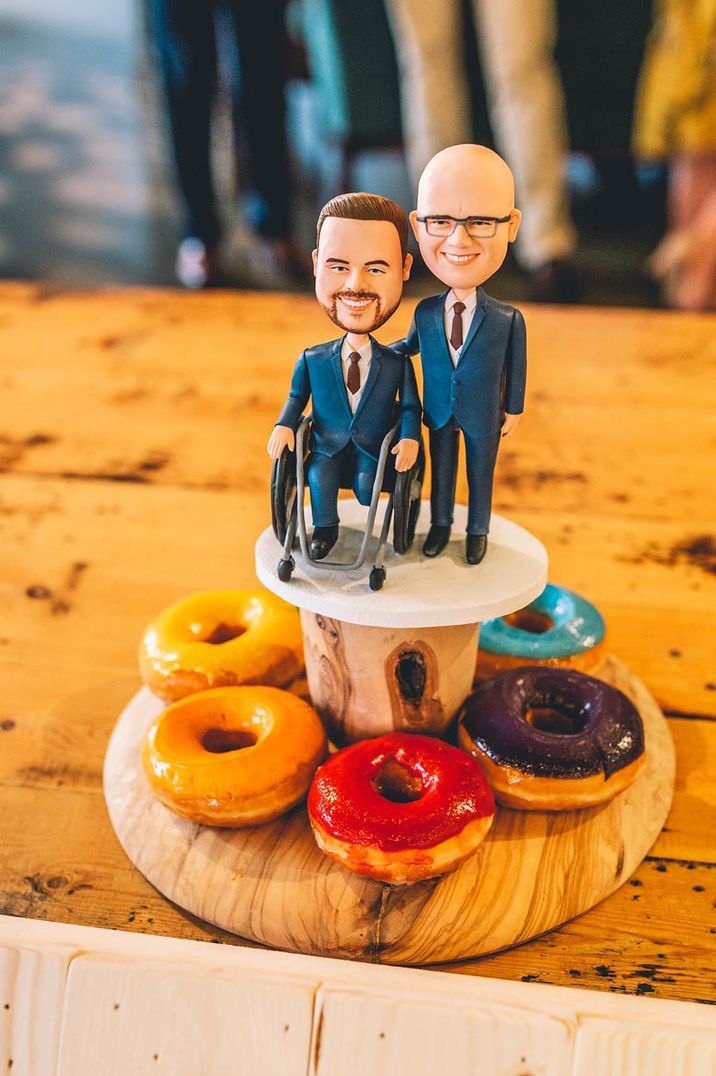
left=256, top=500, right=547, bottom=745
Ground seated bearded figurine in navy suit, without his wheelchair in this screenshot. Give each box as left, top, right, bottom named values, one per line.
left=267, top=194, right=421, bottom=561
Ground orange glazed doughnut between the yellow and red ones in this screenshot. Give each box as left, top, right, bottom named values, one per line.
left=142, top=686, right=326, bottom=826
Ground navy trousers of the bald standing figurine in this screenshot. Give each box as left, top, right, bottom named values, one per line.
left=430, top=419, right=500, bottom=535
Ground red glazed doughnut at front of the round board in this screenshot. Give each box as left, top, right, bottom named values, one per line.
left=308, top=733, right=494, bottom=886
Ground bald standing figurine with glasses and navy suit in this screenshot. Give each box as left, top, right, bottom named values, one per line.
left=394, top=145, right=527, bottom=564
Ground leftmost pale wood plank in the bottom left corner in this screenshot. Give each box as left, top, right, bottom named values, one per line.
left=0, top=946, right=71, bottom=1076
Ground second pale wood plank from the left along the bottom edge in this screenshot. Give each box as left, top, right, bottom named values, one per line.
left=57, top=955, right=313, bottom=1076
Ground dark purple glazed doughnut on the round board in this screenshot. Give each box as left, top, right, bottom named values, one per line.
left=458, top=665, right=644, bottom=810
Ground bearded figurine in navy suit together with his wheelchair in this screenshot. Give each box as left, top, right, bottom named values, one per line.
left=268, top=194, right=424, bottom=590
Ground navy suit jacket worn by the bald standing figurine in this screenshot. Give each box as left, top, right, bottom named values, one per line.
left=393, top=287, right=527, bottom=437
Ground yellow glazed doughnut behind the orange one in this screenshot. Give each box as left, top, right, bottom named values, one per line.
left=139, top=591, right=304, bottom=702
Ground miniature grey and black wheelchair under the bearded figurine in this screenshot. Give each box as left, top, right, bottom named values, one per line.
left=271, top=415, right=425, bottom=591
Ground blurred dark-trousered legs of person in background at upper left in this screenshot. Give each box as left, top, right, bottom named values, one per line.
left=148, top=0, right=296, bottom=287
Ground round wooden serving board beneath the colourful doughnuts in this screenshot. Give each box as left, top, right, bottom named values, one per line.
left=104, top=657, right=675, bottom=964
